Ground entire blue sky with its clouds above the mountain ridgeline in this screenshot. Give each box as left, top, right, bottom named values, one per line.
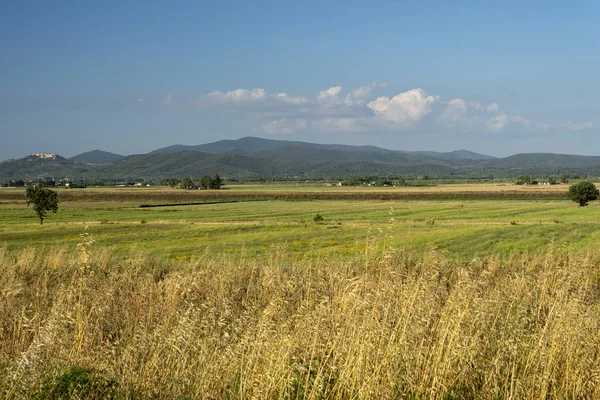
left=0, top=1, right=600, bottom=160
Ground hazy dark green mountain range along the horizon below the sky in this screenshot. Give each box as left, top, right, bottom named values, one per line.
left=0, top=137, right=600, bottom=181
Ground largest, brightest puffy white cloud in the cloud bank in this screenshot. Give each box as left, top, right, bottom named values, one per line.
left=367, top=89, right=439, bottom=123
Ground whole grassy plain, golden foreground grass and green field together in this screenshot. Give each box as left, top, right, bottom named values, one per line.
left=0, top=184, right=600, bottom=399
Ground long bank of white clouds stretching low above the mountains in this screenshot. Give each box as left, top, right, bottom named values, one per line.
left=135, top=83, right=593, bottom=135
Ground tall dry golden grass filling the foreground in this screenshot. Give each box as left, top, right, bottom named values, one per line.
left=0, top=238, right=600, bottom=399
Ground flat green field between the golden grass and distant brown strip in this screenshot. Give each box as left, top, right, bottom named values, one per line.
left=0, top=189, right=600, bottom=258
